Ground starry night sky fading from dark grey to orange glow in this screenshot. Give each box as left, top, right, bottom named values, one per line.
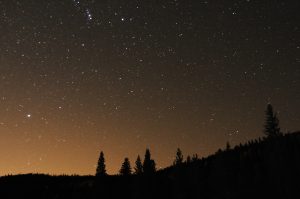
left=0, top=0, right=300, bottom=175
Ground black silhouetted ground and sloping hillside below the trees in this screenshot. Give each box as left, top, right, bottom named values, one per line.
left=0, top=132, right=300, bottom=199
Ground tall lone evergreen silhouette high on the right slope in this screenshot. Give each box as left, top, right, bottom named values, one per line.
left=264, top=104, right=281, bottom=137
